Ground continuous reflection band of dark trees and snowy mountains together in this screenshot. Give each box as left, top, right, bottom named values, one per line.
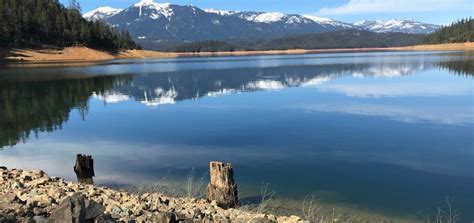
left=0, top=57, right=473, bottom=148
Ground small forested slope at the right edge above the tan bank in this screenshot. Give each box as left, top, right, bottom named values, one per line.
left=423, top=18, right=474, bottom=44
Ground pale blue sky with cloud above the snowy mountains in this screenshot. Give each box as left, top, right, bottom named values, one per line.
left=60, top=0, right=474, bottom=24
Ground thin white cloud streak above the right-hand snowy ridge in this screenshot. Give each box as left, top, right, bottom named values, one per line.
left=318, top=0, right=472, bottom=15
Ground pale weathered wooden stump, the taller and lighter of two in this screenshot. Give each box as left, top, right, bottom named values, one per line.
left=207, top=162, right=238, bottom=208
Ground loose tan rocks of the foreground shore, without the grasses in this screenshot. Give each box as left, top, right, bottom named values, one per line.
left=0, top=167, right=302, bottom=223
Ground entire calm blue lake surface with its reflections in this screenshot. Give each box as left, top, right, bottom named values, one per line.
left=0, top=52, right=474, bottom=219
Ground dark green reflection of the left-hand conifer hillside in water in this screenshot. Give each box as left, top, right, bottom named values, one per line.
left=0, top=76, right=131, bottom=148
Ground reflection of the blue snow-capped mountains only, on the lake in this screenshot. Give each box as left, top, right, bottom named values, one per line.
left=99, top=63, right=426, bottom=107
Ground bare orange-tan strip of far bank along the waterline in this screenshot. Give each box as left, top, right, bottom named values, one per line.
left=0, top=42, right=474, bottom=65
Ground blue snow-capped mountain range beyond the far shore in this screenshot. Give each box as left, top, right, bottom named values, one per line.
left=83, top=0, right=440, bottom=48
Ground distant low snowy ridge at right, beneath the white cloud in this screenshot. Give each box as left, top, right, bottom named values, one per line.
left=353, top=19, right=441, bottom=34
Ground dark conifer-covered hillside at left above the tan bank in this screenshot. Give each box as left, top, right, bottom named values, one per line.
left=0, top=0, right=139, bottom=50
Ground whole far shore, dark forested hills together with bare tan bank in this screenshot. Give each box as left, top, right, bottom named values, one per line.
left=0, top=0, right=474, bottom=62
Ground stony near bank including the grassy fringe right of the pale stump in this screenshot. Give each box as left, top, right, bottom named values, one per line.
left=0, top=167, right=421, bottom=223
